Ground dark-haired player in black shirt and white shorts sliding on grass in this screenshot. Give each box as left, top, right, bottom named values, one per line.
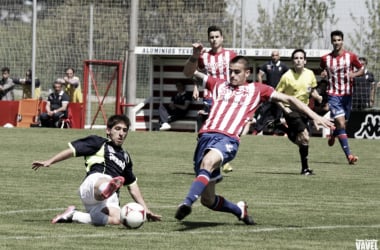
left=32, top=115, right=161, bottom=226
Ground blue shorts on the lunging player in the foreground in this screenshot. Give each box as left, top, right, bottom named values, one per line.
left=194, top=133, right=239, bottom=181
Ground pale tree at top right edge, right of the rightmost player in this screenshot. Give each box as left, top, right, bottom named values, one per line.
left=348, top=0, right=380, bottom=81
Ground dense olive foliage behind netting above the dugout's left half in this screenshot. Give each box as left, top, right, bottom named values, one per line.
left=139, top=0, right=232, bottom=47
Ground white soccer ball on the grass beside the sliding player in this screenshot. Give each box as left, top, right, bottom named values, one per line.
left=120, top=202, right=146, bottom=229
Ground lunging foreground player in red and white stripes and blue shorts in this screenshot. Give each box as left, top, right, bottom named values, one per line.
left=175, top=47, right=333, bottom=225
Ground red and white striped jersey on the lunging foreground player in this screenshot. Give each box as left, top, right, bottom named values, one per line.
left=199, top=77, right=274, bottom=140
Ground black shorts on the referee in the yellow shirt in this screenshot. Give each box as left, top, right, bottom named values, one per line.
left=284, top=111, right=309, bottom=142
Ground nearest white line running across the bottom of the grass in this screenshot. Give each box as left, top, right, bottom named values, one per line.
left=0, top=225, right=380, bottom=240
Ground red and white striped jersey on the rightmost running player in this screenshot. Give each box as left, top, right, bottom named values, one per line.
left=320, top=51, right=363, bottom=96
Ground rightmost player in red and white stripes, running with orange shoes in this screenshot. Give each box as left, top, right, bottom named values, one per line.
left=320, top=30, right=364, bottom=164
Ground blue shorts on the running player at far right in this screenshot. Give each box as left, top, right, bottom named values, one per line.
left=328, top=95, right=352, bottom=120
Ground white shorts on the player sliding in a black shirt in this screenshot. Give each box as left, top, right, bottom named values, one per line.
left=79, top=173, right=120, bottom=214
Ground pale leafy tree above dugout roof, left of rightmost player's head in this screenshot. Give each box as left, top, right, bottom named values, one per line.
left=246, top=0, right=338, bottom=49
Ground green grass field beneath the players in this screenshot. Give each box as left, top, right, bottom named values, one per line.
left=0, top=128, right=380, bottom=250
